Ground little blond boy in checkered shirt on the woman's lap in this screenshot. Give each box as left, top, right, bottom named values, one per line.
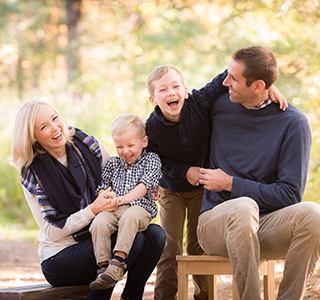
left=90, top=113, right=161, bottom=290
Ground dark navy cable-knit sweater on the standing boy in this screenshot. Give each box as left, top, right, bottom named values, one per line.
left=146, top=71, right=228, bottom=192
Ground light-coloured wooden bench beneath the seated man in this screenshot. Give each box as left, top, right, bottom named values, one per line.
left=176, top=255, right=275, bottom=300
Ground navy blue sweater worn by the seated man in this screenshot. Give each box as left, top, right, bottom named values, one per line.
left=201, top=94, right=311, bottom=215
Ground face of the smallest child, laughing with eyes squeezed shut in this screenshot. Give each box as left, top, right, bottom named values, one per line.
left=113, top=129, right=148, bottom=166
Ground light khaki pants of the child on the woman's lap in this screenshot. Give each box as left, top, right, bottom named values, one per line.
left=89, top=205, right=151, bottom=264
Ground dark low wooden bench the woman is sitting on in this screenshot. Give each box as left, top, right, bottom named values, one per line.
left=0, top=284, right=90, bottom=300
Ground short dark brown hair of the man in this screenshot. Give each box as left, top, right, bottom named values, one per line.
left=232, top=46, right=279, bottom=89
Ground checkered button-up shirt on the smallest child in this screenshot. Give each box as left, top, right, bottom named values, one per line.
left=97, top=150, right=162, bottom=218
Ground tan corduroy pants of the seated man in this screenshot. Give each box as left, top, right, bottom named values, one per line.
left=198, top=197, right=320, bottom=300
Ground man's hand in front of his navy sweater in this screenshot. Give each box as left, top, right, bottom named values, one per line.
left=200, top=168, right=233, bottom=192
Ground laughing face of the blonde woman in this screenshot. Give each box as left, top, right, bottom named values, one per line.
left=34, top=104, right=67, bottom=158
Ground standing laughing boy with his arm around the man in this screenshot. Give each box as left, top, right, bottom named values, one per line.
left=146, top=65, right=285, bottom=300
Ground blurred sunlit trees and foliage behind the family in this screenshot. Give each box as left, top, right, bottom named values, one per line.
left=0, top=0, right=320, bottom=224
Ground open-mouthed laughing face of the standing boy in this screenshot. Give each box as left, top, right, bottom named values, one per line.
left=149, top=70, right=188, bottom=122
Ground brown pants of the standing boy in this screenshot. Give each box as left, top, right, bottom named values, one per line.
left=154, top=187, right=208, bottom=300
